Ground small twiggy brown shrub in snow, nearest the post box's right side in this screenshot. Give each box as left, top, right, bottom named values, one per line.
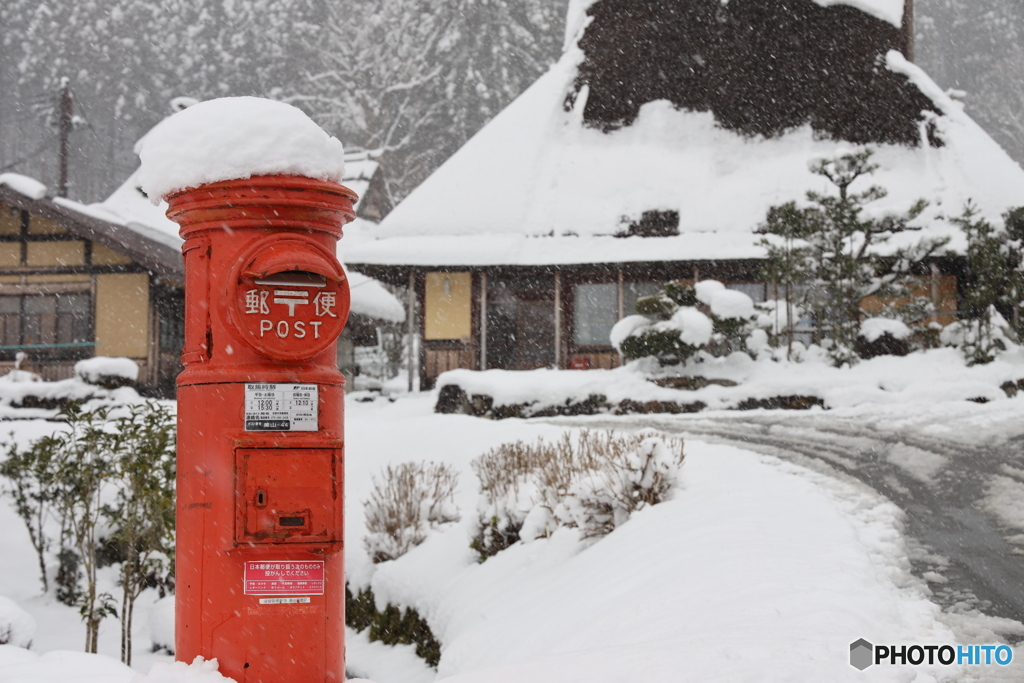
left=362, top=462, right=459, bottom=563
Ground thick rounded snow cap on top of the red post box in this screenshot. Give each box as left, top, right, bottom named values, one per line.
left=135, top=97, right=345, bottom=204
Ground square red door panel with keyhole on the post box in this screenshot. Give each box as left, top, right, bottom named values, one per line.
left=234, top=449, right=342, bottom=544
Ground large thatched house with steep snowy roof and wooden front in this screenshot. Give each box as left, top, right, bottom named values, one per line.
left=345, top=0, right=1024, bottom=387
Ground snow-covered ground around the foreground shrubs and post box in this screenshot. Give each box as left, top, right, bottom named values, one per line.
left=0, top=376, right=1024, bottom=683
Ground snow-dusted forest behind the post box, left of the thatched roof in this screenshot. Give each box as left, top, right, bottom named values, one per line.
left=0, top=0, right=566, bottom=201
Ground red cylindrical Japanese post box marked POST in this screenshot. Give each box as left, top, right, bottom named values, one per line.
left=167, top=176, right=356, bottom=683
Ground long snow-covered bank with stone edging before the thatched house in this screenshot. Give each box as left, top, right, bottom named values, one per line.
left=438, top=348, right=1024, bottom=413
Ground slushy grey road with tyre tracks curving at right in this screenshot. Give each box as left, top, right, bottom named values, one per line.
left=559, top=401, right=1024, bottom=634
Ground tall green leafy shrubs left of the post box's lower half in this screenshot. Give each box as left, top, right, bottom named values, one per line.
left=0, top=401, right=175, bottom=664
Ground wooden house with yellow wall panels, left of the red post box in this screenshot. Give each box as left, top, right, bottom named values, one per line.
left=0, top=174, right=183, bottom=390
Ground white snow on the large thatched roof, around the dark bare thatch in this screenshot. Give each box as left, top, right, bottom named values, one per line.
left=346, top=0, right=1024, bottom=266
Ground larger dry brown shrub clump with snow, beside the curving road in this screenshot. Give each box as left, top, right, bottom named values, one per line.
left=472, top=430, right=685, bottom=558
